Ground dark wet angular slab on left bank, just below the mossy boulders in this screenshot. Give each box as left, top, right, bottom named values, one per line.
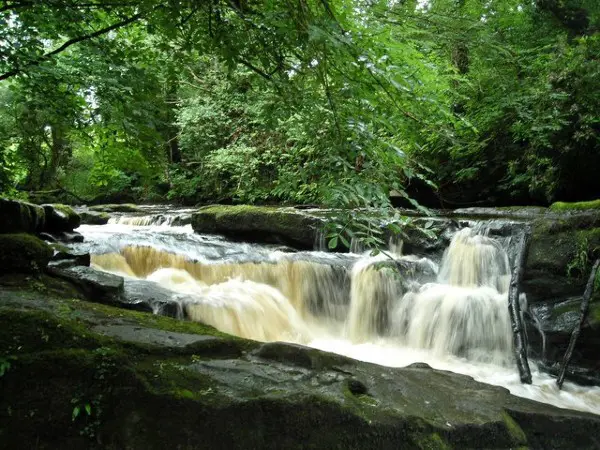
left=48, top=266, right=124, bottom=305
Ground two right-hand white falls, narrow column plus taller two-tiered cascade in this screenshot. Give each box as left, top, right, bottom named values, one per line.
left=346, top=228, right=512, bottom=364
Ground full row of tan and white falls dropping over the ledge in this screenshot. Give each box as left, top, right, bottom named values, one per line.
left=92, top=228, right=512, bottom=362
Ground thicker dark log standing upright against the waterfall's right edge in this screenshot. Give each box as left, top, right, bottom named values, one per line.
left=508, top=229, right=531, bottom=384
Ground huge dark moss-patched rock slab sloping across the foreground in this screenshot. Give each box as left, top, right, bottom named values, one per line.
left=0, top=284, right=600, bottom=450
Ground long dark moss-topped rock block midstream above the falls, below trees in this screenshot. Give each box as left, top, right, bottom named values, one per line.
left=192, top=205, right=322, bottom=249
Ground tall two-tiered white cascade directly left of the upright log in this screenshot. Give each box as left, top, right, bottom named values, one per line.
left=393, top=228, right=512, bottom=364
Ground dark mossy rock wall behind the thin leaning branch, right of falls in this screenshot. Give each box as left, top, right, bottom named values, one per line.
left=523, top=210, right=600, bottom=383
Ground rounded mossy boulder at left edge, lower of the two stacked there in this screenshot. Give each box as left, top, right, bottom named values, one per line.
left=0, top=234, right=53, bottom=273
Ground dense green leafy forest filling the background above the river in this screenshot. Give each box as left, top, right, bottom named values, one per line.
left=0, top=0, right=600, bottom=207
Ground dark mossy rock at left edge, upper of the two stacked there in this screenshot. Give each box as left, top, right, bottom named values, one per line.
left=0, top=198, right=46, bottom=233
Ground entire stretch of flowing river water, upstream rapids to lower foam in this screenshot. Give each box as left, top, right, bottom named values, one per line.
left=78, top=214, right=600, bottom=414
